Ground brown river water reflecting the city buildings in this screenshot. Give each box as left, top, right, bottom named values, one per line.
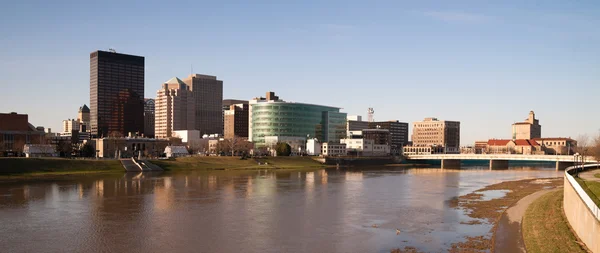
left=0, top=165, right=564, bottom=252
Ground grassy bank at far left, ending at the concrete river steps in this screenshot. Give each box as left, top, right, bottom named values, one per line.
left=0, top=158, right=124, bottom=176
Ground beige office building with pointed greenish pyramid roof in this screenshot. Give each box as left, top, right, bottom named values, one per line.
left=154, top=77, right=196, bottom=138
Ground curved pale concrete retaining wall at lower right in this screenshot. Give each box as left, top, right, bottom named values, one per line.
left=563, top=165, right=600, bottom=253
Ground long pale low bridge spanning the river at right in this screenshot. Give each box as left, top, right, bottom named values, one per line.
left=406, top=154, right=597, bottom=170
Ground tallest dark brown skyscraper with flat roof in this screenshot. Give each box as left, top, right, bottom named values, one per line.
left=90, top=51, right=144, bottom=136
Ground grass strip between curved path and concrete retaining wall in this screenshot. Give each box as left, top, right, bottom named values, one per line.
left=523, top=190, right=586, bottom=253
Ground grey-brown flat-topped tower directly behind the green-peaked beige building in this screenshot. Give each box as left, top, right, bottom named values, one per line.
left=183, top=74, right=223, bottom=135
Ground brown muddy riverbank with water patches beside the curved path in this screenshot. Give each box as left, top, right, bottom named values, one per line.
left=449, top=178, right=563, bottom=252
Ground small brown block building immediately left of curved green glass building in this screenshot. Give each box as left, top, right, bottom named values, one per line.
left=223, top=103, right=249, bottom=139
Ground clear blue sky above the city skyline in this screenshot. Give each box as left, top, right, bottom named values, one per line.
left=0, top=0, right=600, bottom=145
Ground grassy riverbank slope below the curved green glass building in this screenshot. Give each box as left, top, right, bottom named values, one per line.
left=151, top=156, right=325, bottom=171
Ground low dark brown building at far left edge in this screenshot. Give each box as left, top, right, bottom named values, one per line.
left=0, top=112, right=46, bottom=156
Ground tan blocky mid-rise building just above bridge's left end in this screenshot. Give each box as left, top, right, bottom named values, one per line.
left=412, top=118, right=460, bottom=153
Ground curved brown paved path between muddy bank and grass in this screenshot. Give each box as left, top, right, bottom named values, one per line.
left=494, top=189, right=556, bottom=253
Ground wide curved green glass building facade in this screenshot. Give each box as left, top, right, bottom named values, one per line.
left=250, top=102, right=346, bottom=145
